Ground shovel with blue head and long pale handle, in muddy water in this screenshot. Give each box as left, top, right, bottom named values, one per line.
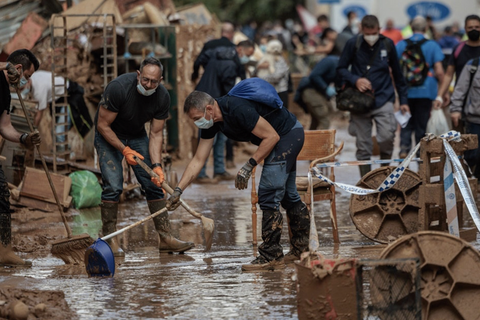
left=85, top=208, right=167, bottom=277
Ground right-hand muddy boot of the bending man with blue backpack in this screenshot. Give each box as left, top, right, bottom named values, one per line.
left=285, top=201, right=310, bottom=263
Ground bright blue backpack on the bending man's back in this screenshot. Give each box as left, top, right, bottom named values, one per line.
left=227, top=78, right=283, bottom=109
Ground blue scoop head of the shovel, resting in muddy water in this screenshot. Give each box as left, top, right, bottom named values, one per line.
left=85, top=239, right=115, bottom=277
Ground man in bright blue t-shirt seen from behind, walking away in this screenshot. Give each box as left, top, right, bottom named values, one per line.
left=397, top=16, right=444, bottom=159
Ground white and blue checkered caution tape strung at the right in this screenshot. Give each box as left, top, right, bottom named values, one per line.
left=311, top=130, right=480, bottom=232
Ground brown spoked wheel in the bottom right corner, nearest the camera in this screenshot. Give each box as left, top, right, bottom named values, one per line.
left=380, top=231, right=480, bottom=320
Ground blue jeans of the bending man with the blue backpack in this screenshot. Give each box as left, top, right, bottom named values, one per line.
left=258, top=121, right=305, bottom=211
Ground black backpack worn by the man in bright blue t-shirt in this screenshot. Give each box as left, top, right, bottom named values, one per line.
left=400, top=39, right=429, bottom=87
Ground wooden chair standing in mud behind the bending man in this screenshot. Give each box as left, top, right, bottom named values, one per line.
left=251, top=129, right=343, bottom=245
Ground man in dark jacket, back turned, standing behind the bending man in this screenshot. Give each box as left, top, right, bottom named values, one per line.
left=192, top=22, right=248, bottom=183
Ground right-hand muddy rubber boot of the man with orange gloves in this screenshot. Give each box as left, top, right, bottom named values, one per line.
left=148, top=200, right=195, bottom=253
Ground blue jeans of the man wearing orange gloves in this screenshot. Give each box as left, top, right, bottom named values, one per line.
left=94, top=130, right=165, bottom=202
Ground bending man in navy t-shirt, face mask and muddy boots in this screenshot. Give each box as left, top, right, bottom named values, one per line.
left=167, top=89, right=310, bottom=271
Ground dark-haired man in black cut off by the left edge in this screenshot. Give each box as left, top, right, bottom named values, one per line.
left=0, top=49, right=41, bottom=266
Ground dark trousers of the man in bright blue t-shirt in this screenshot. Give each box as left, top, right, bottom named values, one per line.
left=400, top=99, right=432, bottom=153
